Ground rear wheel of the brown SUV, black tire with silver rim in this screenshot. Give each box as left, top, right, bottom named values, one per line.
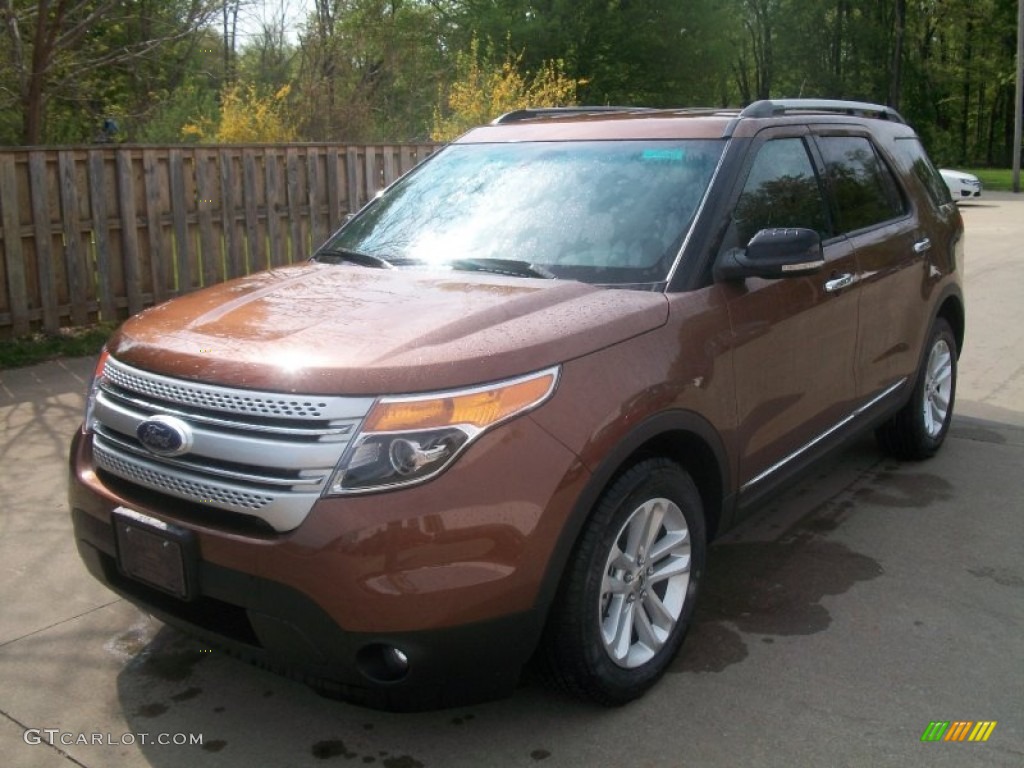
left=874, top=317, right=957, bottom=461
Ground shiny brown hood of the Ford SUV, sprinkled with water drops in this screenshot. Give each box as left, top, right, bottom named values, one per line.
left=109, top=263, right=668, bottom=395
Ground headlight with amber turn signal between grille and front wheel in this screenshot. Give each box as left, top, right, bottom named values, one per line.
left=326, top=368, right=558, bottom=496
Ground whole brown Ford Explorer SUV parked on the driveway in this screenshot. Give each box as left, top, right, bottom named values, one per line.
left=70, top=100, right=965, bottom=710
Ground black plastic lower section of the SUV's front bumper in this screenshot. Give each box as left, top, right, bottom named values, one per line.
left=72, top=509, right=543, bottom=711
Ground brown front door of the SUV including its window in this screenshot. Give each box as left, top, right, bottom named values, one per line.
left=722, top=132, right=858, bottom=496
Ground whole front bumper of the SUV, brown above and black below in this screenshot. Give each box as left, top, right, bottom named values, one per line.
left=70, top=419, right=585, bottom=711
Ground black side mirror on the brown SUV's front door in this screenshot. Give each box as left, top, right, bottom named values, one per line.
left=715, top=227, right=825, bottom=281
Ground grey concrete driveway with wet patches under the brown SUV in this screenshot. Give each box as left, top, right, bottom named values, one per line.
left=0, top=194, right=1024, bottom=768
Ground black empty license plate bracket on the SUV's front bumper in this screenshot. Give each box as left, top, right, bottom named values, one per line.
left=114, top=507, right=199, bottom=600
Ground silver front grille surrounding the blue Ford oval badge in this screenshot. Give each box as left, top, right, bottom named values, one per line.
left=90, top=357, right=373, bottom=531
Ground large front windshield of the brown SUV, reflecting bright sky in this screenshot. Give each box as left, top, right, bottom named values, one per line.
left=314, top=140, right=724, bottom=285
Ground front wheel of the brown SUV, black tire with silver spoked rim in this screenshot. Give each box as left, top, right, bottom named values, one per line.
left=544, top=459, right=707, bottom=707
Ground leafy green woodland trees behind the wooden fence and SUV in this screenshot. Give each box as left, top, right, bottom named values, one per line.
left=0, top=0, right=1017, bottom=163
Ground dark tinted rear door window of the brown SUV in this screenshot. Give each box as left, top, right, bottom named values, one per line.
left=819, top=136, right=905, bottom=232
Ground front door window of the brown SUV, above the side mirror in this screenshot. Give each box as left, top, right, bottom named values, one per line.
left=728, top=138, right=830, bottom=248
